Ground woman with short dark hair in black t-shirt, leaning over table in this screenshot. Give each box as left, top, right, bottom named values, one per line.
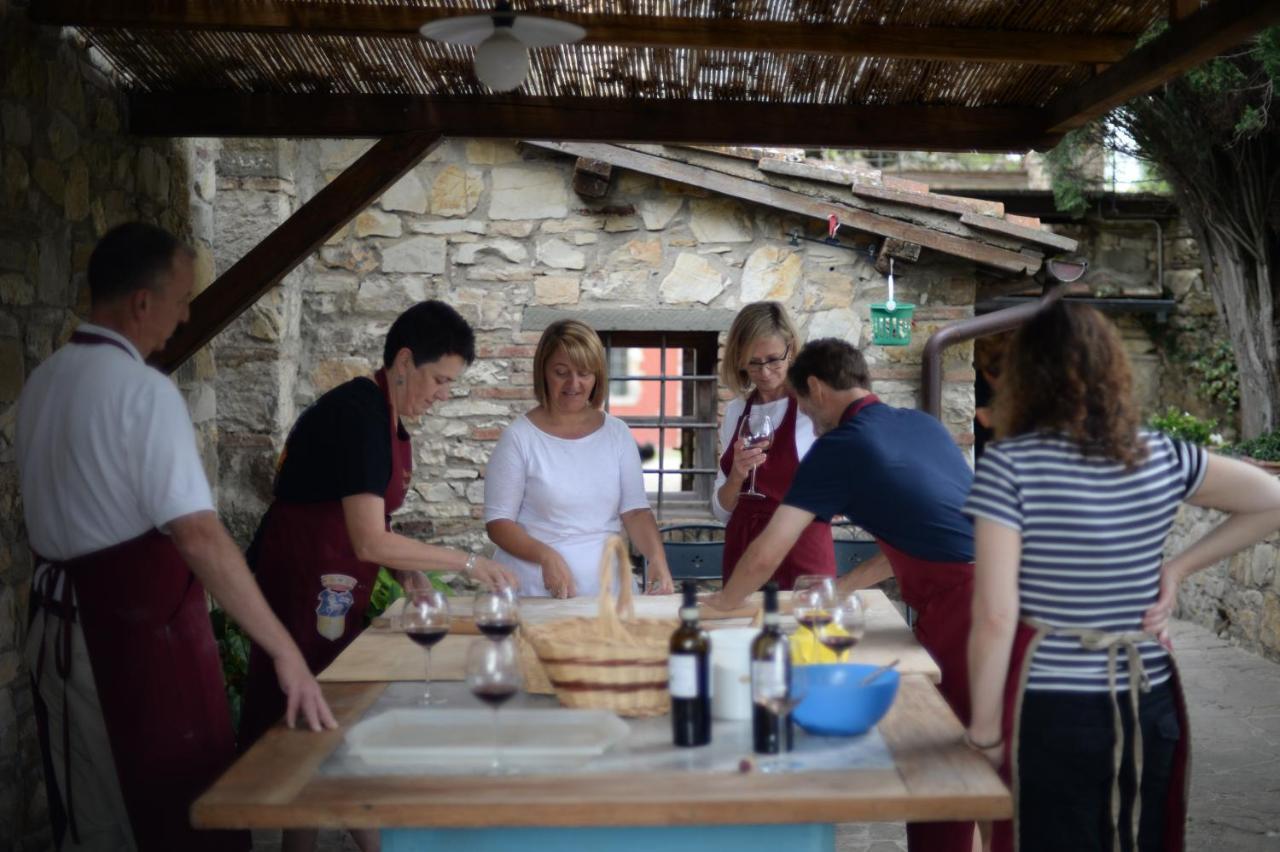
left=239, top=301, right=515, bottom=846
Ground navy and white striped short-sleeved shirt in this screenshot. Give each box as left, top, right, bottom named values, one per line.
left=964, top=431, right=1207, bottom=692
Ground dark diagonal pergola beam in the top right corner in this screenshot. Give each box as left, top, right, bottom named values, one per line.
left=1046, top=0, right=1280, bottom=134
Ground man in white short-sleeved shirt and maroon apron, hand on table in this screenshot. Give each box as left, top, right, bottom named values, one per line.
left=17, top=224, right=337, bottom=851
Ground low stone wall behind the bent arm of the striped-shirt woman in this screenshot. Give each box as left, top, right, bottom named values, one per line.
left=1165, top=505, right=1280, bottom=661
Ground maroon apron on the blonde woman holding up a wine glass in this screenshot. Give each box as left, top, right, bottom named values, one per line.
left=721, top=393, right=836, bottom=591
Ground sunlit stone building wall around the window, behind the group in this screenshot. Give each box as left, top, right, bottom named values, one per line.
left=209, top=141, right=975, bottom=555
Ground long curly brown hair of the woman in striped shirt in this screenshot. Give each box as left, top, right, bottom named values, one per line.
left=995, top=301, right=1147, bottom=469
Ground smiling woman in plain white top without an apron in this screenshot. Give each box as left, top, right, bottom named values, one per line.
left=484, top=320, right=673, bottom=597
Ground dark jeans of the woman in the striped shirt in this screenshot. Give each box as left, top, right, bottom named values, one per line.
left=1018, top=683, right=1181, bottom=852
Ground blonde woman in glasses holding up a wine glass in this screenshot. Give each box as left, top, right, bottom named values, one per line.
left=712, top=302, right=836, bottom=590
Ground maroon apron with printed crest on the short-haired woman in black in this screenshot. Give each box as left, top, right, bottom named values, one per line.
left=239, top=370, right=413, bottom=751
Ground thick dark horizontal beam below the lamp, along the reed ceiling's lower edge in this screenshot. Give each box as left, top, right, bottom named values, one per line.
left=129, top=93, right=1055, bottom=151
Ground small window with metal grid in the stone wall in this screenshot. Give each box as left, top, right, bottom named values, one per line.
left=600, top=331, right=717, bottom=521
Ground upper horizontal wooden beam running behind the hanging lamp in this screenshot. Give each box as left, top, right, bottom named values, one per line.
left=31, top=0, right=1137, bottom=65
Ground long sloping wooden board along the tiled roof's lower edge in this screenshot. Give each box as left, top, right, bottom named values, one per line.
left=529, top=141, right=1039, bottom=272
